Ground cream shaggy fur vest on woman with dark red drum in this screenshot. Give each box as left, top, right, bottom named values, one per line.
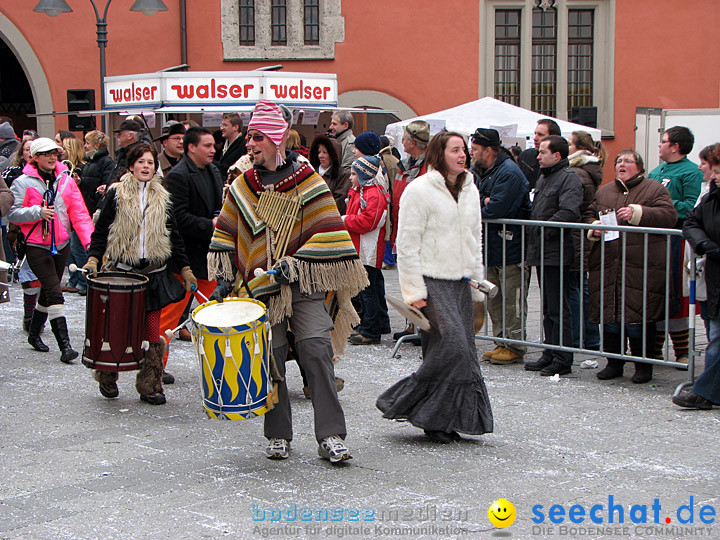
left=105, top=173, right=172, bottom=267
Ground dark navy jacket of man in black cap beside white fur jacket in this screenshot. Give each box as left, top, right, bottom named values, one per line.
left=479, top=152, right=530, bottom=266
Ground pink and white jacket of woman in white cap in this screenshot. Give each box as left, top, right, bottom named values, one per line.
left=8, top=162, right=94, bottom=249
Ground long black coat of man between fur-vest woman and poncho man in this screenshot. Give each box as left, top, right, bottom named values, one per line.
left=165, top=154, right=223, bottom=279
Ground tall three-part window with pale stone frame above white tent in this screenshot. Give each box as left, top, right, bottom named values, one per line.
left=479, top=0, right=616, bottom=133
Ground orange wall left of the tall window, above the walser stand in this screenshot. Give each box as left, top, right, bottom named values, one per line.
left=0, top=0, right=478, bottom=127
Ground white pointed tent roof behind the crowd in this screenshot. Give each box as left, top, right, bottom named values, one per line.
left=385, top=97, right=601, bottom=152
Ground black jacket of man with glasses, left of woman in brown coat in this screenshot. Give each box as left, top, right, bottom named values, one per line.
left=526, top=159, right=582, bottom=266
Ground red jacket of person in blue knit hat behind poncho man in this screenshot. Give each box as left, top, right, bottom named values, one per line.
left=343, top=184, right=388, bottom=268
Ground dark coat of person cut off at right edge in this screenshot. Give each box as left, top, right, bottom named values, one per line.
left=683, top=185, right=720, bottom=319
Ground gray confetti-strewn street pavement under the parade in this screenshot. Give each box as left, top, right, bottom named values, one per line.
left=0, top=271, right=720, bottom=540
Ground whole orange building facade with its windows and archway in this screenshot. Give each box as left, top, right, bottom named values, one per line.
left=0, top=0, right=720, bottom=173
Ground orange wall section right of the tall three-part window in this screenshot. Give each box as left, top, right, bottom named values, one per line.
left=605, top=0, right=720, bottom=180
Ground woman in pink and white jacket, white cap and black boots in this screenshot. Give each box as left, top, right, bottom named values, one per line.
left=8, top=137, right=93, bottom=364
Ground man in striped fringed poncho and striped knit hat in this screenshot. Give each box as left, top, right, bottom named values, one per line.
left=208, top=101, right=368, bottom=463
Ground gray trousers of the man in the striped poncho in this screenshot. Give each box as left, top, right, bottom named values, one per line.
left=265, top=283, right=347, bottom=442
